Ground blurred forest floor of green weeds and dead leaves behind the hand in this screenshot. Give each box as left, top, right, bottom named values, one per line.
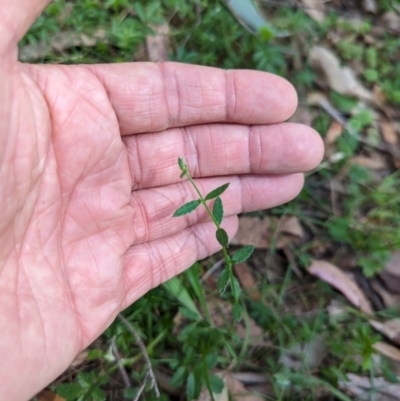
left=26, top=0, right=400, bottom=401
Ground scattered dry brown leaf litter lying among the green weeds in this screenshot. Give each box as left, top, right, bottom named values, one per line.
left=29, top=0, right=400, bottom=401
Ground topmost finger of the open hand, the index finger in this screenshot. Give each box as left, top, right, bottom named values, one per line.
left=88, top=62, right=297, bottom=135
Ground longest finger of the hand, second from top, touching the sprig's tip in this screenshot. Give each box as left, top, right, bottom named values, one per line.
left=123, top=123, right=323, bottom=189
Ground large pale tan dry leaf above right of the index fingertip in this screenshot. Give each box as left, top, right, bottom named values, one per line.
left=310, top=46, right=373, bottom=101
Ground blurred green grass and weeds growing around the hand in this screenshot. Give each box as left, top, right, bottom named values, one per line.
left=26, top=0, right=400, bottom=401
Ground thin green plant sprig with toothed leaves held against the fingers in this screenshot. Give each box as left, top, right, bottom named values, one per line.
left=173, top=158, right=254, bottom=320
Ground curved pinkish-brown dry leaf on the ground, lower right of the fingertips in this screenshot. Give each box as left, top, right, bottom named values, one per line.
left=308, top=260, right=372, bottom=314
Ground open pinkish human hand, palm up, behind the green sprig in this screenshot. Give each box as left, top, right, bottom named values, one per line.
left=0, top=0, right=322, bottom=400
